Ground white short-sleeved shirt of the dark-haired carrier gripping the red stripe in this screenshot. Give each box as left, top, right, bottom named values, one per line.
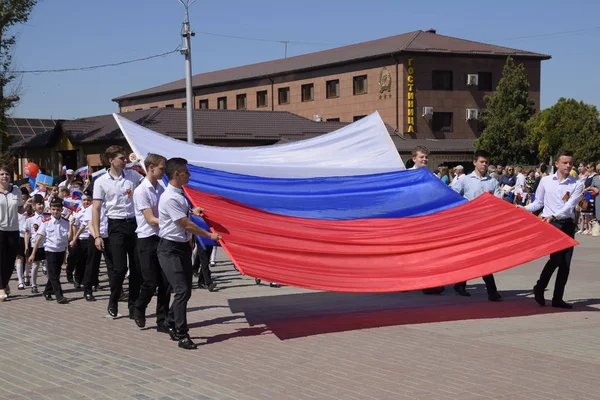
left=158, top=185, right=191, bottom=242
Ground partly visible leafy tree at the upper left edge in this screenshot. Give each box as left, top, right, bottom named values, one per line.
left=0, top=0, right=38, bottom=160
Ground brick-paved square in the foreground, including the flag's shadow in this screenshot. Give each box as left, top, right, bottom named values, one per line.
left=0, top=237, right=600, bottom=400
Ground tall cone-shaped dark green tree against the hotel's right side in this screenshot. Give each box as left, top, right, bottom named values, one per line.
left=475, top=57, right=536, bottom=164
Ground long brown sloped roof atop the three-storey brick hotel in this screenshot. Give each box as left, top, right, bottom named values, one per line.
left=113, top=30, right=550, bottom=102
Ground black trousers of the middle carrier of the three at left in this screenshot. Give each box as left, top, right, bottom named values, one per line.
left=135, top=235, right=171, bottom=326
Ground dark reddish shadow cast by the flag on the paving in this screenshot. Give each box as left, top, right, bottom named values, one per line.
left=229, top=285, right=600, bottom=340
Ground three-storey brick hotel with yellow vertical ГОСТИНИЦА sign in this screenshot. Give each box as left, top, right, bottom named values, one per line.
left=113, top=30, right=550, bottom=162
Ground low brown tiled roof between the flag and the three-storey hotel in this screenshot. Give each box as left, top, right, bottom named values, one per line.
left=13, top=108, right=475, bottom=152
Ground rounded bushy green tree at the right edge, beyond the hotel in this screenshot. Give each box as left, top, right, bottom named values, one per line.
left=528, top=98, right=600, bottom=161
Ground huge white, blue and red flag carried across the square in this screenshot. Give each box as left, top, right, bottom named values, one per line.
left=115, top=114, right=577, bottom=292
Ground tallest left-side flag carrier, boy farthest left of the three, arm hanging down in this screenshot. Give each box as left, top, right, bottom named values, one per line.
left=92, top=146, right=143, bottom=319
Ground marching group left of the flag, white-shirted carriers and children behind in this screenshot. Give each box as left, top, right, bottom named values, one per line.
left=0, top=146, right=220, bottom=349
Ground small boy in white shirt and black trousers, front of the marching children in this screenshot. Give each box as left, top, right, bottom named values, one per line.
left=29, top=200, right=69, bottom=304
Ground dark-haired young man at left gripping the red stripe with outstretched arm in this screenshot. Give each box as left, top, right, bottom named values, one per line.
left=157, top=158, right=221, bottom=350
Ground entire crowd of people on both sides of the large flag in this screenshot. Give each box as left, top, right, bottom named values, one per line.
left=0, top=146, right=600, bottom=349
